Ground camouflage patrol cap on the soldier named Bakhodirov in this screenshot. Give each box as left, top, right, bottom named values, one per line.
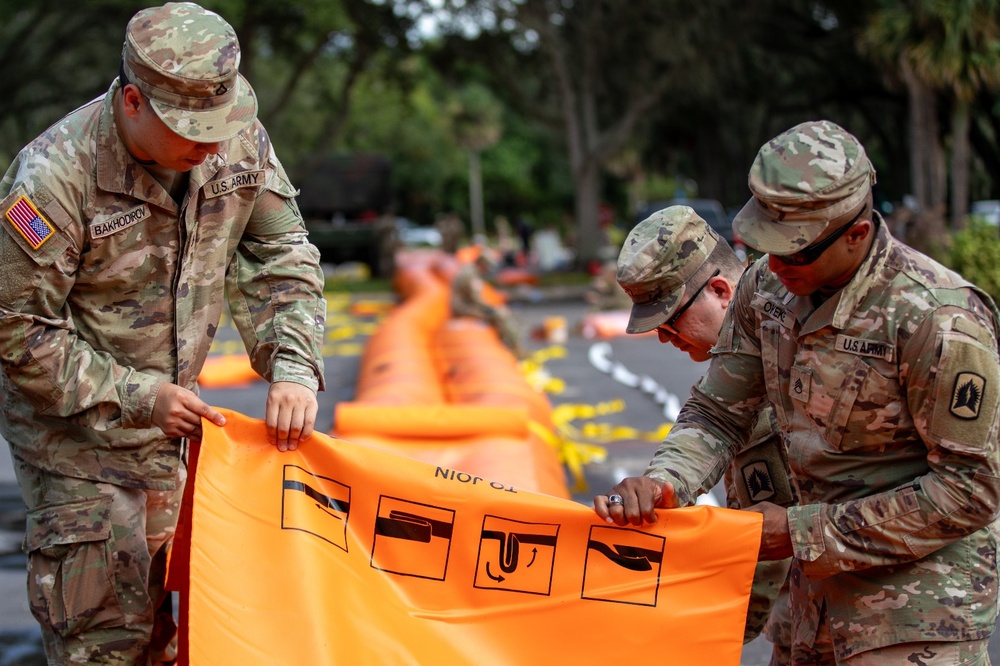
left=122, top=2, right=257, bottom=143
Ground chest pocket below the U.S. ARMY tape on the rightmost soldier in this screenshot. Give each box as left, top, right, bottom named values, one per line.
left=826, top=357, right=909, bottom=451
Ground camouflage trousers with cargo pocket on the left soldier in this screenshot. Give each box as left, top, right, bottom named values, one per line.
left=14, top=458, right=187, bottom=665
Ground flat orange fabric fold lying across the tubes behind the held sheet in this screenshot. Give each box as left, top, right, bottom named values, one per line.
left=334, top=402, right=528, bottom=439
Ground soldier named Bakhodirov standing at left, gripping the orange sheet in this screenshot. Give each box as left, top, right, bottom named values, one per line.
left=0, top=3, right=326, bottom=664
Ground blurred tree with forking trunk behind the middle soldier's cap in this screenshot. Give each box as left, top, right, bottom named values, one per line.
left=432, top=0, right=744, bottom=263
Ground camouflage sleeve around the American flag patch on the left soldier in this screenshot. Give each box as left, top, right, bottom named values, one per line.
left=0, top=161, right=161, bottom=431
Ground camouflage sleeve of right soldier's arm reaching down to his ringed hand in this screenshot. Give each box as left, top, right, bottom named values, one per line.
left=645, top=264, right=767, bottom=506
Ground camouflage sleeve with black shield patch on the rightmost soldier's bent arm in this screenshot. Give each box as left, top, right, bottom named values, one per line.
left=788, top=307, right=1000, bottom=580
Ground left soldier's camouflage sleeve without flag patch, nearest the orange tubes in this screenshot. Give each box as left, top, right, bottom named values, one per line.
left=226, top=140, right=326, bottom=391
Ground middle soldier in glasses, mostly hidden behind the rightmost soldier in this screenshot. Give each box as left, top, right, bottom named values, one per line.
left=617, top=206, right=795, bottom=664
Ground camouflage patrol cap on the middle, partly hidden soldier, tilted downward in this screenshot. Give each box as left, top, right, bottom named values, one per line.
left=617, top=206, right=725, bottom=333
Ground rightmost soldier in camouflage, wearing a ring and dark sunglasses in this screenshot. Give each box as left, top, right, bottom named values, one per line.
left=595, top=121, right=1000, bottom=666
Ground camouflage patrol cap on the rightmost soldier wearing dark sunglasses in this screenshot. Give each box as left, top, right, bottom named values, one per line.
left=733, top=120, right=875, bottom=255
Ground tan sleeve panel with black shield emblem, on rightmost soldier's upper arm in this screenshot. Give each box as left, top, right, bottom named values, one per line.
left=930, top=333, right=1000, bottom=449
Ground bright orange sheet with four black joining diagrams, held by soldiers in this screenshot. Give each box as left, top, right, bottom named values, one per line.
left=170, top=410, right=760, bottom=666
